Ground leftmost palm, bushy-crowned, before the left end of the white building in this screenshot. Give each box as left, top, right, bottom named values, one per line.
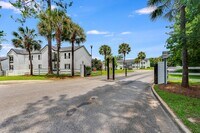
left=12, top=27, right=41, bottom=75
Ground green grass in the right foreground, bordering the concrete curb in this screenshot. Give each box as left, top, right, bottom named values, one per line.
left=155, top=85, right=200, bottom=133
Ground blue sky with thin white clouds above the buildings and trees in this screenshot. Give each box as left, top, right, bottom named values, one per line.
left=0, top=0, right=170, bottom=59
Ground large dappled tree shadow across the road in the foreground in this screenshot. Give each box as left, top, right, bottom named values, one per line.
left=0, top=78, right=178, bottom=133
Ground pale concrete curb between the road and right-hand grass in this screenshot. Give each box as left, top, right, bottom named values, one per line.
left=151, top=84, right=191, bottom=133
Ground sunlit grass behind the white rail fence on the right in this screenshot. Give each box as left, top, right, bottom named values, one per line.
left=168, top=74, right=200, bottom=85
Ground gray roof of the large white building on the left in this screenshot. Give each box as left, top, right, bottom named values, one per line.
left=8, top=45, right=84, bottom=55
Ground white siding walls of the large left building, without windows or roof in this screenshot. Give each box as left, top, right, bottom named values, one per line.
left=4, top=46, right=91, bottom=75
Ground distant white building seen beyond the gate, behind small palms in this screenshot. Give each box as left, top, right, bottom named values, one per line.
left=117, top=58, right=150, bottom=69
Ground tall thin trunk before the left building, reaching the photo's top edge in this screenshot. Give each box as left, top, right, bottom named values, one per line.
left=47, top=0, right=53, bottom=74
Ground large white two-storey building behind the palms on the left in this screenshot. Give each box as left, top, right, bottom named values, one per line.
left=2, top=45, right=91, bottom=75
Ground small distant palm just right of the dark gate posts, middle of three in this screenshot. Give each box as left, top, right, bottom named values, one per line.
left=118, top=43, right=131, bottom=68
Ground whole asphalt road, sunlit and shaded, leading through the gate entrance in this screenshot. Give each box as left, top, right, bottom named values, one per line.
left=0, top=71, right=179, bottom=133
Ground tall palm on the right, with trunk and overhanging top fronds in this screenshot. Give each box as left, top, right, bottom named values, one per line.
left=148, top=0, right=189, bottom=87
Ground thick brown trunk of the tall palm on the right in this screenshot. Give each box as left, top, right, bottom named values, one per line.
left=180, top=5, right=189, bottom=87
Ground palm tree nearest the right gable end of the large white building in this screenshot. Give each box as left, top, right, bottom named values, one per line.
left=64, top=22, right=86, bottom=76
